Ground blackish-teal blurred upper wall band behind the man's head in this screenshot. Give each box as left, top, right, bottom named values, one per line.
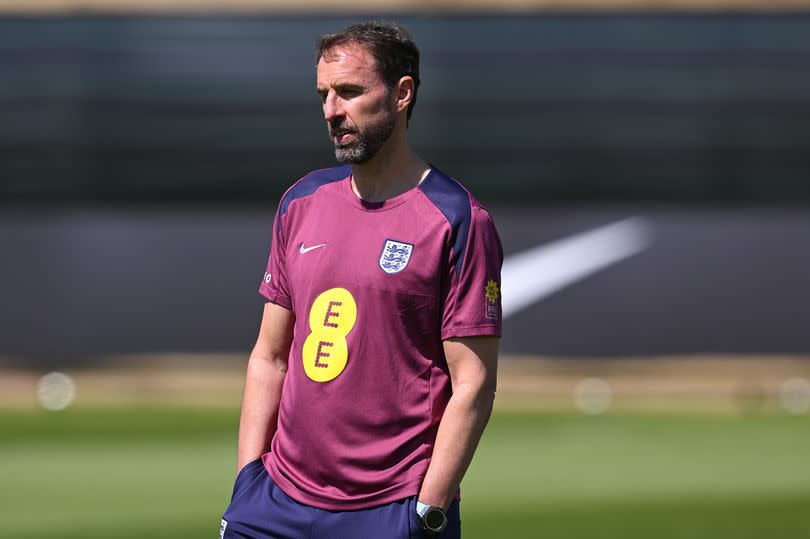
left=0, top=14, right=810, bottom=206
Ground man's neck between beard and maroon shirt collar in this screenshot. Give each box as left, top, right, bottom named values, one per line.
left=352, top=131, right=430, bottom=202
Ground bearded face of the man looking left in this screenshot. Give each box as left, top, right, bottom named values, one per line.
left=317, top=45, right=396, bottom=164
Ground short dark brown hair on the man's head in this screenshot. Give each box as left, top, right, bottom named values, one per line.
left=315, top=21, right=419, bottom=120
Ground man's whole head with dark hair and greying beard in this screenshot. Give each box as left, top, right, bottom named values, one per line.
left=315, top=22, right=419, bottom=163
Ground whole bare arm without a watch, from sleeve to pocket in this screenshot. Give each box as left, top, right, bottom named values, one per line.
left=237, top=302, right=295, bottom=472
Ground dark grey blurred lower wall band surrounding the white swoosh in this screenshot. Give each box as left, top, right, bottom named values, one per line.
left=0, top=202, right=810, bottom=366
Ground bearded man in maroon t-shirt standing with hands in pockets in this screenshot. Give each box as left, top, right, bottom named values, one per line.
left=221, top=23, right=503, bottom=539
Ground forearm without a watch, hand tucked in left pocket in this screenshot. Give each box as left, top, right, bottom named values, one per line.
left=237, top=355, right=287, bottom=471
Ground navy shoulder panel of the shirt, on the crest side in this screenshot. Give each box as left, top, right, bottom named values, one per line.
left=419, top=166, right=472, bottom=276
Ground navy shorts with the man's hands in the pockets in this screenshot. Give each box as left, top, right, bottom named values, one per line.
left=220, top=459, right=461, bottom=539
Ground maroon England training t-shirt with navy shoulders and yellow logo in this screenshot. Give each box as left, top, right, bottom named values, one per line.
left=259, top=166, right=503, bottom=510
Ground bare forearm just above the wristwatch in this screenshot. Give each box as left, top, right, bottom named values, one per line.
left=419, top=383, right=495, bottom=509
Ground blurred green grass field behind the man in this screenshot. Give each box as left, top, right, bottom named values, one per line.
left=0, top=408, right=810, bottom=539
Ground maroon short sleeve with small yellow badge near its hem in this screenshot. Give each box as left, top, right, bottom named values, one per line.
left=442, top=205, right=503, bottom=340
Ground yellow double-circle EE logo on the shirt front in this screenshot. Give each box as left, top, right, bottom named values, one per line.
left=301, top=288, right=357, bottom=382
